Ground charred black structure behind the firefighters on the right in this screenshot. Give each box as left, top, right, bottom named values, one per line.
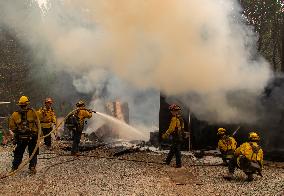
left=159, top=76, right=284, bottom=161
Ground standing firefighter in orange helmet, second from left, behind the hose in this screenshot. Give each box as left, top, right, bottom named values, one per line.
left=37, top=97, right=56, bottom=149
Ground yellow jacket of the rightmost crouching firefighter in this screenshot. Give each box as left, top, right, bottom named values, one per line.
left=235, top=142, right=263, bottom=166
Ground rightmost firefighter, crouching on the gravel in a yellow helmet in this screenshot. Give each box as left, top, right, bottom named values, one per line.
left=225, top=132, right=263, bottom=181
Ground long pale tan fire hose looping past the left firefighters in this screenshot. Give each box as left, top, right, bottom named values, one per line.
left=0, top=109, right=86, bottom=179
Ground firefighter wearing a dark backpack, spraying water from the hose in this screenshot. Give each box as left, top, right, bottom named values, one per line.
left=65, top=100, right=95, bottom=155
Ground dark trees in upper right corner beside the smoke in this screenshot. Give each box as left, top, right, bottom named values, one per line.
left=239, top=0, right=284, bottom=71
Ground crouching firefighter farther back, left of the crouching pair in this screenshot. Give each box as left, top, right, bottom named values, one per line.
left=217, top=128, right=237, bottom=165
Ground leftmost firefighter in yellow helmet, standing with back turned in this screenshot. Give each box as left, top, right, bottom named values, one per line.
left=9, top=96, right=39, bottom=174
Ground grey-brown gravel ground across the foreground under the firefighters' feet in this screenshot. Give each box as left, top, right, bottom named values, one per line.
left=0, top=142, right=284, bottom=196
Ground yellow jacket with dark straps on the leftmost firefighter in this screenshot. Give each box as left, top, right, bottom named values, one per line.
left=9, top=108, right=38, bottom=134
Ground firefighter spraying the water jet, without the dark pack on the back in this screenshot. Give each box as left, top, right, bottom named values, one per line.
left=71, top=100, right=92, bottom=155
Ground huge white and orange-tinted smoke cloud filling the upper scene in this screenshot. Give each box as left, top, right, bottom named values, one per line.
left=0, top=0, right=271, bottom=130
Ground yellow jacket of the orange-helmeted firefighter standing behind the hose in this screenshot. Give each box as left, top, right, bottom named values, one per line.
left=37, top=107, right=56, bottom=128
